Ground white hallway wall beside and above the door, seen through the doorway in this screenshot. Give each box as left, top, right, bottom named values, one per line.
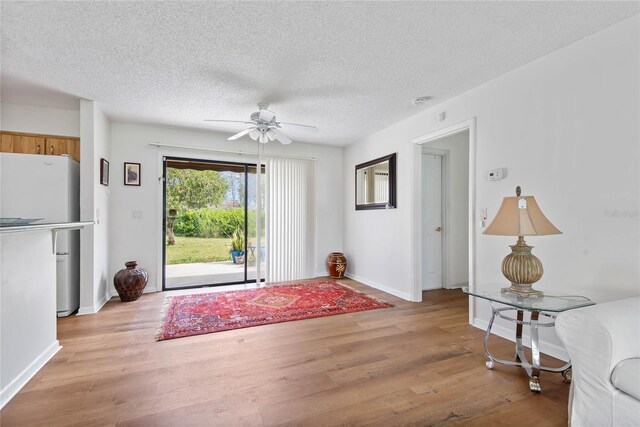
left=423, top=131, right=469, bottom=287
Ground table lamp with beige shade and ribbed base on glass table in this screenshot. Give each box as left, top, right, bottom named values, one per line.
left=482, top=186, right=562, bottom=297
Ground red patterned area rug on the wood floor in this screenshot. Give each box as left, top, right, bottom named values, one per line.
left=156, top=281, right=393, bottom=341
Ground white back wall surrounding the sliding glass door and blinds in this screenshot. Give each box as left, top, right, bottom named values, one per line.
left=108, top=123, right=343, bottom=292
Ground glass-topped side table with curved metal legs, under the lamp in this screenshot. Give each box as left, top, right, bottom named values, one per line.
left=462, top=285, right=595, bottom=392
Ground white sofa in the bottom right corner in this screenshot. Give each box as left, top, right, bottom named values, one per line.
left=556, top=297, right=640, bottom=427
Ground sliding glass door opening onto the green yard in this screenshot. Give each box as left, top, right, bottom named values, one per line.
left=162, top=157, right=265, bottom=290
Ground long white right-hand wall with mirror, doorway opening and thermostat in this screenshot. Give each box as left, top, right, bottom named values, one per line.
left=344, top=16, right=640, bottom=358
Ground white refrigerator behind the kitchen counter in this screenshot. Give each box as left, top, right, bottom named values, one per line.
left=0, top=153, right=80, bottom=317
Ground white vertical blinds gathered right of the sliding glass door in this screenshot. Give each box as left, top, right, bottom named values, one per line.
left=265, top=158, right=315, bottom=282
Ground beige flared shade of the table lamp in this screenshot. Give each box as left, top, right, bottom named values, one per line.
left=482, top=196, right=562, bottom=236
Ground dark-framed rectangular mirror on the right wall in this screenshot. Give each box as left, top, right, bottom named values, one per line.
left=356, top=153, right=396, bottom=211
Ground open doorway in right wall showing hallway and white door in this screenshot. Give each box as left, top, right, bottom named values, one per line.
left=421, top=129, right=470, bottom=290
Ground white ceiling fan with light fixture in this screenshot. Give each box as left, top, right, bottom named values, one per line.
left=205, top=102, right=318, bottom=145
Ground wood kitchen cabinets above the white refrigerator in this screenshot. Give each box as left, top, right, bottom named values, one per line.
left=0, top=132, right=80, bottom=162
